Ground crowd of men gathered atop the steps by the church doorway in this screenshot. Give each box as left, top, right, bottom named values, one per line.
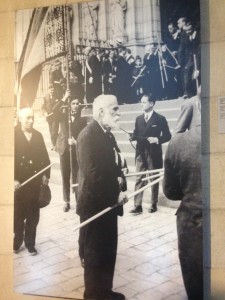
left=47, top=17, right=200, bottom=104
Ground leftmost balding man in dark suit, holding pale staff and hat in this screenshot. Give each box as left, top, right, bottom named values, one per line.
left=13, top=108, right=50, bottom=255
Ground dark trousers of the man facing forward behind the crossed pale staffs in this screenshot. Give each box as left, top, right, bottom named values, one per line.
left=134, top=152, right=159, bottom=206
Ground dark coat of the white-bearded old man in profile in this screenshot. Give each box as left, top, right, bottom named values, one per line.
left=77, top=120, right=122, bottom=218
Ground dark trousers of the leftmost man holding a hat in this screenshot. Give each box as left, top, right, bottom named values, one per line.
left=13, top=191, right=40, bottom=250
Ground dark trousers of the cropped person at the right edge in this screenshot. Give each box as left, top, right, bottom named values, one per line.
left=177, top=209, right=203, bottom=300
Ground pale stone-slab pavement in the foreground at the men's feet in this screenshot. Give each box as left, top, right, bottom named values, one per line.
left=14, top=183, right=187, bottom=300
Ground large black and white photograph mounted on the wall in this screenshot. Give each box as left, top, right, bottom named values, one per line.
left=13, top=0, right=203, bottom=300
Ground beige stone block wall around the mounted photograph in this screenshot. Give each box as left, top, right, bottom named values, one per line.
left=0, top=0, right=225, bottom=300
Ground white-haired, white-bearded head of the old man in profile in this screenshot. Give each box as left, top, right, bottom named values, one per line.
left=93, top=95, right=119, bottom=129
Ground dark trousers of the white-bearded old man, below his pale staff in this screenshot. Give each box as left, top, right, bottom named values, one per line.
left=83, top=211, right=117, bottom=300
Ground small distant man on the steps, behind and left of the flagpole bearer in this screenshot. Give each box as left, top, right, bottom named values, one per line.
left=42, top=83, right=59, bottom=149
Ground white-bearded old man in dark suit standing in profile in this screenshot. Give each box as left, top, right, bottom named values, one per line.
left=77, top=95, right=126, bottom=300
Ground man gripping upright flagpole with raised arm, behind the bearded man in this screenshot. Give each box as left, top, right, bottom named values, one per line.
left=53, top=91, right=87, bottom=212
